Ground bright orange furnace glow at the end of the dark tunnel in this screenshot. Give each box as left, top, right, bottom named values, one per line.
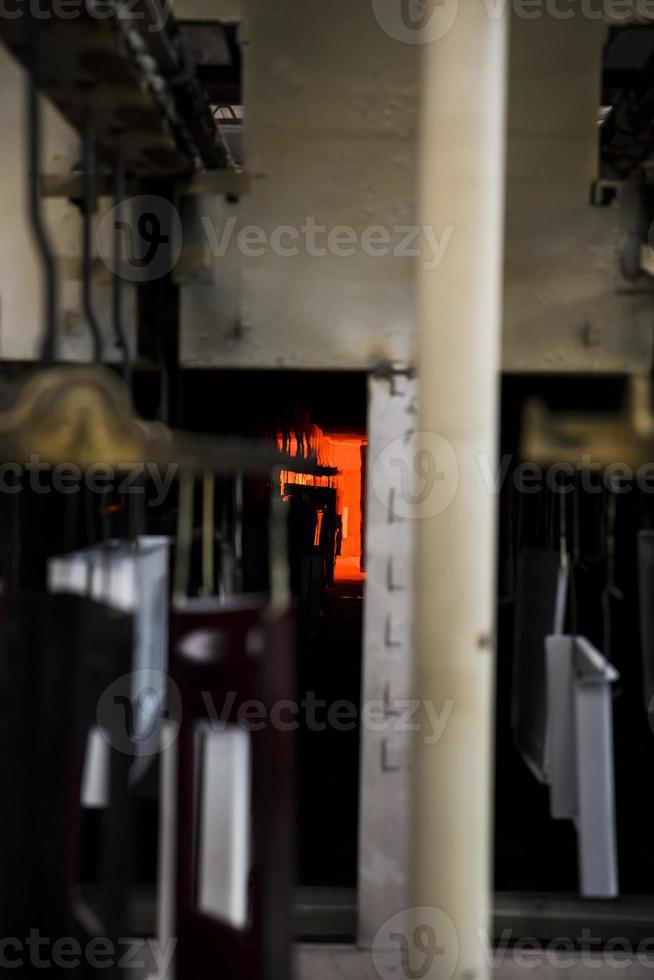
left=277, top=425, right=366, bottom=581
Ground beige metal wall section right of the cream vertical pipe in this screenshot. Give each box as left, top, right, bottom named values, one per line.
left=503, top=10, right=654, bottom=373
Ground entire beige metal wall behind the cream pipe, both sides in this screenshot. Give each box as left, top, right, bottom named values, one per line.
left=182, top=0, right=654, bottom=373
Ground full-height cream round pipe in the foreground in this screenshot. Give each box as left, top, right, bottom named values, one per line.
left=410, top=0, right=507, bottom=980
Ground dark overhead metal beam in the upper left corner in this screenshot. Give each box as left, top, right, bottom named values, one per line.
left=0, top=0, right=226, bottom=175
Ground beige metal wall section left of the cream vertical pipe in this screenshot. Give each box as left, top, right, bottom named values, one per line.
left=181, top=0, right=418, bottom=368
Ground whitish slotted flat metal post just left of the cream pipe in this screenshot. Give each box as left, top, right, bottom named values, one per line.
left=357, top=373, right=416, bottom=948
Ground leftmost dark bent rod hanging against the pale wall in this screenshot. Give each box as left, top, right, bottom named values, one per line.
left=26, top=73, right=59, bottom=364
